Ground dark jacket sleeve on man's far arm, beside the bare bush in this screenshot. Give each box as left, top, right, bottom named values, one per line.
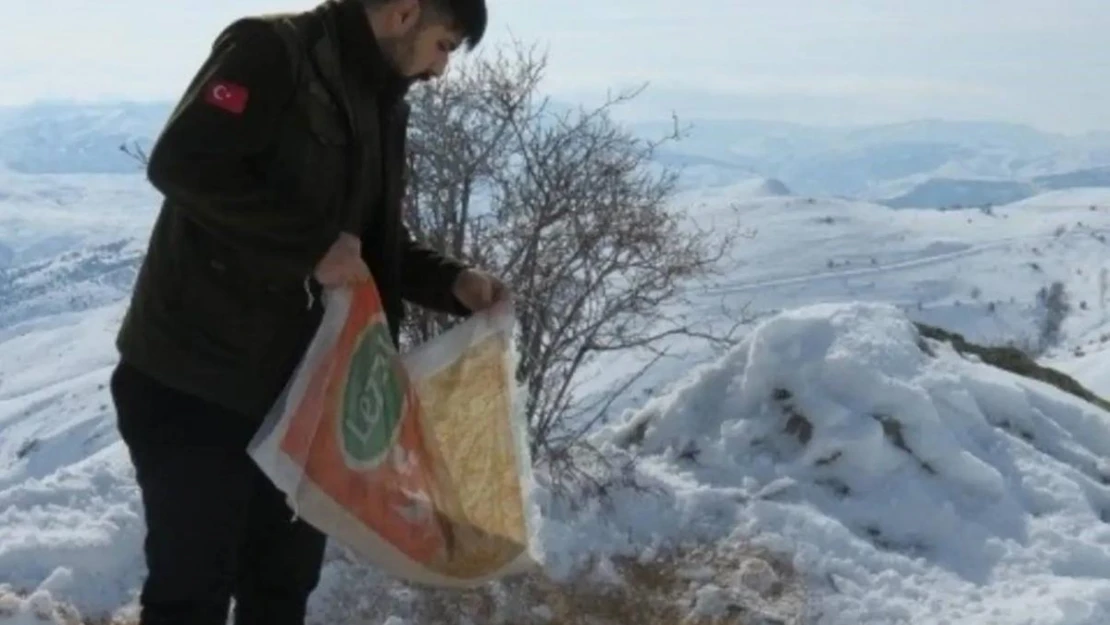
left=401, top=224, right=471, bottom=316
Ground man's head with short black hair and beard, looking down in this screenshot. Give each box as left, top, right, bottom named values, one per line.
left=362, top=0, right=487, bottom=80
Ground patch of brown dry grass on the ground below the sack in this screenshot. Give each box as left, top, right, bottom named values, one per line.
left=316, top=539, right=806, bottom=625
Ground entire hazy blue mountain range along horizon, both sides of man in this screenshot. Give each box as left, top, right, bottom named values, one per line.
left=8, top=102, right=1110, bottom=205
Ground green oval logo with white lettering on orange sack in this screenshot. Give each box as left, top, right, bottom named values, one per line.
left=340, top=323, right=405, bottom=470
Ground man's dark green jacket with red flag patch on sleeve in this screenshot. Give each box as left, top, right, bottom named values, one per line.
left=117, top=0, right=468, bottom=417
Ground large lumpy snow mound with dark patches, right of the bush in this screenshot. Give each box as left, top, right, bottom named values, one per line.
left=590, top=303, right=1110, bottom=625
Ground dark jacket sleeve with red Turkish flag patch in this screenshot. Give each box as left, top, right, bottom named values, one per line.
left=147, top=20, right=335, bottom=279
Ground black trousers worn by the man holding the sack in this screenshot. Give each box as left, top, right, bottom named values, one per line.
left=111, top=364, right=326, bottom=625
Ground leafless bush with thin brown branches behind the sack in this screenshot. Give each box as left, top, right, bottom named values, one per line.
left=406, top=44, right=748, bottom=460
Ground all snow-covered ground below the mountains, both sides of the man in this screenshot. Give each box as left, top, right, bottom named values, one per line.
left=0, top=172, right=1110, bottom=625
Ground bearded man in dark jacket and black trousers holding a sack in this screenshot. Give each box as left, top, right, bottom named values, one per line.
left=111, top=0, right=505, bottom=625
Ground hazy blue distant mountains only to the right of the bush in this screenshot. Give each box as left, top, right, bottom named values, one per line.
left=634, top=119, right=1110, bottom=206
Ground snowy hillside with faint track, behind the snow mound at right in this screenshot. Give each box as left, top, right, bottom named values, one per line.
left=678, top=183, right=1110, bottom=350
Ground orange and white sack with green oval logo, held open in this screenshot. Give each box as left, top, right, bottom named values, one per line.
left=248, top=282, right=536, bottom=587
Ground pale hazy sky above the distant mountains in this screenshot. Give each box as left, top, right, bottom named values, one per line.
left=0, top=0, right=1110, bottom=132
